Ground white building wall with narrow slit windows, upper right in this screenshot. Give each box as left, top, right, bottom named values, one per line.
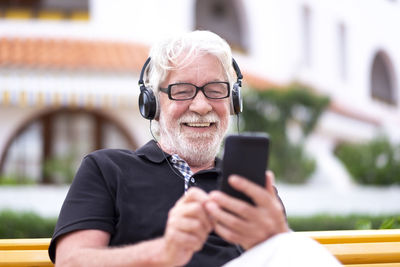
left=241, top=0, right=400, bottom=115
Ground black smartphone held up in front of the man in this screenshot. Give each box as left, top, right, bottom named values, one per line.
left=219, top=133, right=269, bottom=204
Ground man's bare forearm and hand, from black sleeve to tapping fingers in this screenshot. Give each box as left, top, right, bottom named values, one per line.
left=56, top=188, right=212, bottom=267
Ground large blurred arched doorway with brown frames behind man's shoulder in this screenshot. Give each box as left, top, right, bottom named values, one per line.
left=0, top=109, right=137, bottom=183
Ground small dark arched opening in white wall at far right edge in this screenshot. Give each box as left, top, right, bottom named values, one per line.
left=370, top=51, right=398, bottom=105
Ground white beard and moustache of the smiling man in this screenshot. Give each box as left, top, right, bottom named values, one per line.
left=159, top=112, right=229, bottom=166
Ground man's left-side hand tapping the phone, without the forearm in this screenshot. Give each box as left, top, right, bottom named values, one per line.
left=163, top=188, right=212, bottom=266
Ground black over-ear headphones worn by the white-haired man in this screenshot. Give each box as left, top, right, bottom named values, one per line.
left=138, top=57, right=243, bottom=120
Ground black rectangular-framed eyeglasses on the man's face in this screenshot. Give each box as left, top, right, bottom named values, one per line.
left=160, top=82, right=230, bottom=101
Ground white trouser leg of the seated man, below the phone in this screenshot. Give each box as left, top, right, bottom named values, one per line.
left=224, top=232, right=342, bottom=267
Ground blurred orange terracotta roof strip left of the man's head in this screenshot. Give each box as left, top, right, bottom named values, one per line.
left=0, top=37, right=149, bottom=72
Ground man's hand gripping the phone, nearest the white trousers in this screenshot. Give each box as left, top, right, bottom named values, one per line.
left=205, top=171, right=289, bottom=249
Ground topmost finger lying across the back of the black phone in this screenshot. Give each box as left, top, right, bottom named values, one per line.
left=228, top=175, right=271, bottom=206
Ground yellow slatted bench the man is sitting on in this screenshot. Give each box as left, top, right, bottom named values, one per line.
left=0, top=229, right=400, bottom=267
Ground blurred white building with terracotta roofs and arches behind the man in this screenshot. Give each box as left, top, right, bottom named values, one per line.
left=0, top=0, right=400, bottom=186
